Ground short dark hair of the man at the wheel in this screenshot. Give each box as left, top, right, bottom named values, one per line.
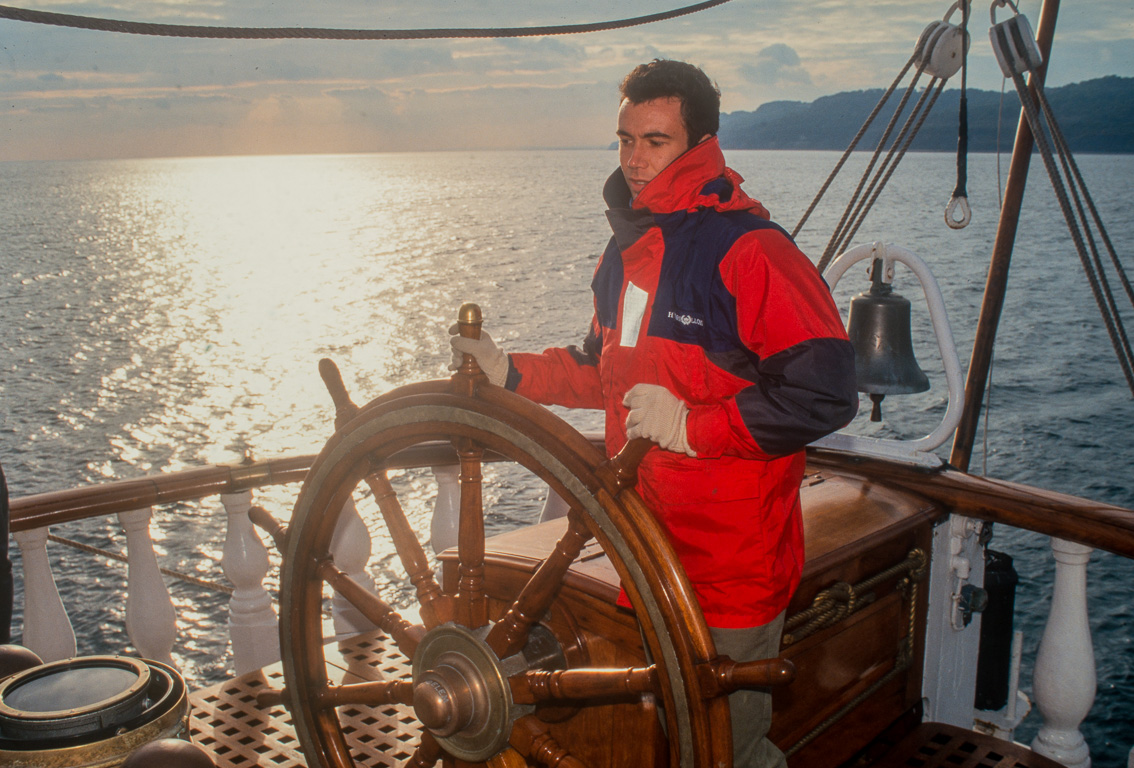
left=618, top=59, right=720, bottom=146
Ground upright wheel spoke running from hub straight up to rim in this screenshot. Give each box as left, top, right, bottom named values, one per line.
left=457, top=439, right=489, bottom=630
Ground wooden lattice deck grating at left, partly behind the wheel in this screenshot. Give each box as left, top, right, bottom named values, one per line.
left=189, top=634, right=421, bottom=768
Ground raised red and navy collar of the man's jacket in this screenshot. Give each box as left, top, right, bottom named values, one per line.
left=603, top=136, right=768, bottom=218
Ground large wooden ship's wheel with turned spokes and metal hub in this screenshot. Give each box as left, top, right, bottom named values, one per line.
left=280, top=305, right=792, bottom=768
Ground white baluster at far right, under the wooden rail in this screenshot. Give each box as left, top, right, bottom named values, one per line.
left=1032, top=539, right=1095, bottom=768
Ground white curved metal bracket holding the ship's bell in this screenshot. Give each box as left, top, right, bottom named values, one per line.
left=811, top=243, right=965, bottom=466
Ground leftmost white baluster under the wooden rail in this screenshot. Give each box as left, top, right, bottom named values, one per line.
left=12, top=528, right=75, bottom=661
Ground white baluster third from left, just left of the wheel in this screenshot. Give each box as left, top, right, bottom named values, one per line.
left=220, top=491, right=280, bottom=675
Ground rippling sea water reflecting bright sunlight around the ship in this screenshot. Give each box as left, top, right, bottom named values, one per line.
left=0, top=151, right=1134, bottom=766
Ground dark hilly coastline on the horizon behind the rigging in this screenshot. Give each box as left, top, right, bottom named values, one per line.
left=719, top=75, right=1134, bottom=153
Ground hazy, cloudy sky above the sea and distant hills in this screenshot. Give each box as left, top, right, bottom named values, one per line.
left=0, top=0, right=1134, bottom=161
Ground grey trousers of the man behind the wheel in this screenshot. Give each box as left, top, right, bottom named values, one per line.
left=709, top=614, right=787, bottom=768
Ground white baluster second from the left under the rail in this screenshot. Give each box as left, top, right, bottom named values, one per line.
left=118, top=507, right=177, bottom=665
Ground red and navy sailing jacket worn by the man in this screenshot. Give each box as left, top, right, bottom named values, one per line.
left=508, top=138, right=857, bottom=627
